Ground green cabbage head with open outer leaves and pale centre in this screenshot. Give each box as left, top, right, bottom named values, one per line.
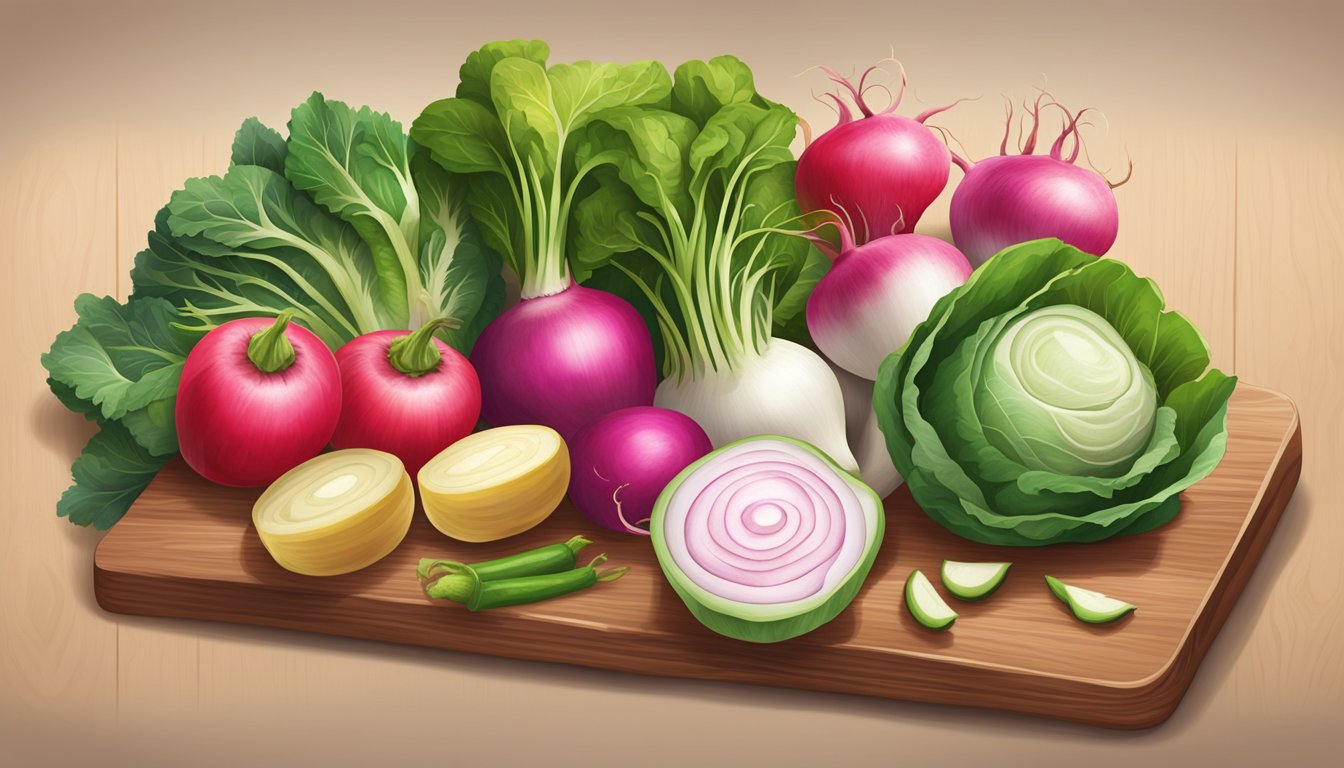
left=874, top=239, right=1236, bottom=546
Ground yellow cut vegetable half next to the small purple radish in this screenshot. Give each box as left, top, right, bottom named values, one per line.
left=418, top=425, right=570, bottom=542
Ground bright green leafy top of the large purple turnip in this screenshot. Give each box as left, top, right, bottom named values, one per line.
left=411, top=40, right=672, bottom=297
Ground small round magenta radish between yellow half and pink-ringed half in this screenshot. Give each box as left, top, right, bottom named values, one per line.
left=570, top=406, right=714, bottom=535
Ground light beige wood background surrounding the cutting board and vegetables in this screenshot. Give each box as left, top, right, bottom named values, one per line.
left=0, top=0, right=1344, bottom=767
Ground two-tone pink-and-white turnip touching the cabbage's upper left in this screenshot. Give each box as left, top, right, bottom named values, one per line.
left=808, top=221, right=970, bottom=379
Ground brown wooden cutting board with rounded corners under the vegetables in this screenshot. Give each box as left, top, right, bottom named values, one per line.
left=94, top=385, right=1302, bottom=728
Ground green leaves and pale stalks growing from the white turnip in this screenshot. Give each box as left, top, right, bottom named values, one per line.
left=573, top=56, right=829, bottom=379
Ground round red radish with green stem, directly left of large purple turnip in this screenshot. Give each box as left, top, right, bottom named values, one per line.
left=332, top=319, right=481, bottom=477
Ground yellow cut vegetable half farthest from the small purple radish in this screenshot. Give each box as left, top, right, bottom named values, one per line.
left=253, top=448, right=415, bottom=576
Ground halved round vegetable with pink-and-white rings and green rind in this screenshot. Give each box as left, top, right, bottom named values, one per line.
left=650, top=436, right=886, bottom=643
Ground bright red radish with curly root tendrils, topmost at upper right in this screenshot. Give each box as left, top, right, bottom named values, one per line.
left=794, top=67, right=956, bottom=245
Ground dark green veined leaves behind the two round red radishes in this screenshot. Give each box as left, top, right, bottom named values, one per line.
left=42, top=94, right=504, bottom=529
